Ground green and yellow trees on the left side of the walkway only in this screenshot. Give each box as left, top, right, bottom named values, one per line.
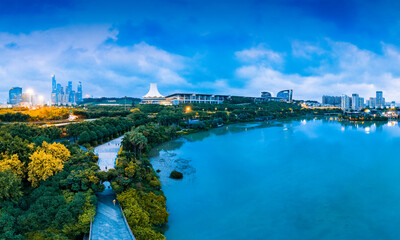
left=0, top=118, right=132, bottom=240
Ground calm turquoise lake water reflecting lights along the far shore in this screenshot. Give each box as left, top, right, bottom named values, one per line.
left=152, top=119, right=400, bottom=240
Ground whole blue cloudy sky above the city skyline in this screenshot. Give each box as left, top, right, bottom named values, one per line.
left=0, top=0, right=400, bottom=102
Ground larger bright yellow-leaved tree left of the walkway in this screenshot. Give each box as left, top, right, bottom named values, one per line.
left=28, top=142, right=71, bottom=187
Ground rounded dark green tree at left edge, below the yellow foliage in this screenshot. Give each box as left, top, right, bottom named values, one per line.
left=0, top=170, right=22, bottom=202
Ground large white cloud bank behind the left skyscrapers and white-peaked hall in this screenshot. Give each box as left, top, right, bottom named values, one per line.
left=0, top=25, right=190, bottom=101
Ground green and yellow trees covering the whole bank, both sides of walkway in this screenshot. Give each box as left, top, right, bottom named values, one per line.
left=0, top=102, right=340, bottom=240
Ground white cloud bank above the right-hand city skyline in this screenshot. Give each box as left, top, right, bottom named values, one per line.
left=231, top=40, right=400, bottom=101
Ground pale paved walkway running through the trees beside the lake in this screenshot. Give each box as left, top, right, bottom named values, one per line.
left=90, top=137, right=135, bottom=240
